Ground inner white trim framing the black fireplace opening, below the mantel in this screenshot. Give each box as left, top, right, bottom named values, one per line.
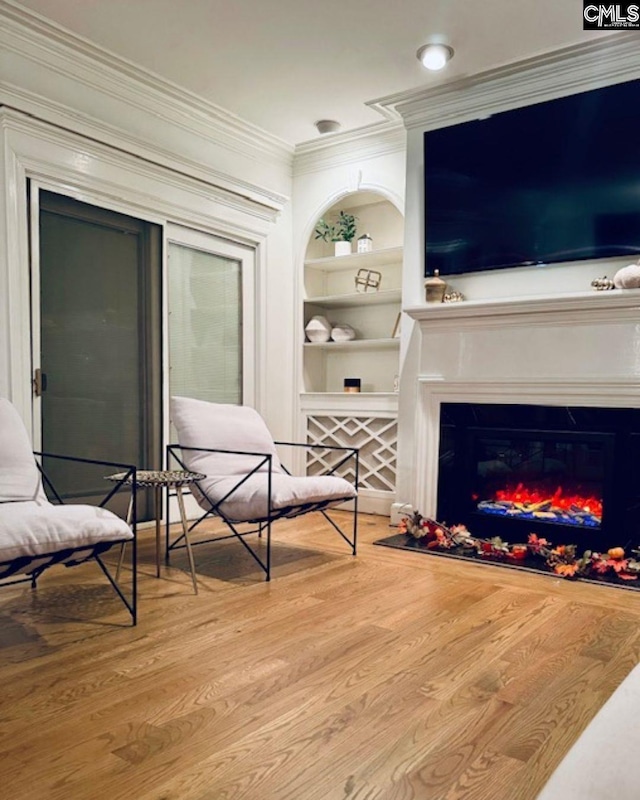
left=411, top=376, right=640, bottom=517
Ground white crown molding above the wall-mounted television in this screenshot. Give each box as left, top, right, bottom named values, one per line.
left=369, top=31, right=640, bottom=130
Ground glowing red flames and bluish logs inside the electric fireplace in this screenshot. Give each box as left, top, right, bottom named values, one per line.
left=473, top=483, right=602, bottom=528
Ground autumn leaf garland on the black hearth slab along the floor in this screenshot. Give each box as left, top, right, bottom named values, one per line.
left=374, top=510, right=640, bottom=589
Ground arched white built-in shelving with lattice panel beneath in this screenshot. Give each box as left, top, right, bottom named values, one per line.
left=300, top=195, right=403, bottom=514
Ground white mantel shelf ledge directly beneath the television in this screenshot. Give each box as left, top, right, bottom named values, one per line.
left=403, top=289, right=640, bottom=331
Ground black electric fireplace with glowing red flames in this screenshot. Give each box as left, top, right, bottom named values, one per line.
left=437, top=402, right=640, bottom=551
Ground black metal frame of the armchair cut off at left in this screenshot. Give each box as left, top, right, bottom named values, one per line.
left=0, top=450, right=138, bottom=625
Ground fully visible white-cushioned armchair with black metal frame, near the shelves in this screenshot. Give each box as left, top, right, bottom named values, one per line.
left=167, top=397, right=358, bottom=580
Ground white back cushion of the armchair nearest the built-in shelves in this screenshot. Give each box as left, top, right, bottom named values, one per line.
left=171, top=397, right=283, bottom=477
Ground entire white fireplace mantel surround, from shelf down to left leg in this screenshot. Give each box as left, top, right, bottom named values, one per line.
left=402, top=289, right=640, bottom=515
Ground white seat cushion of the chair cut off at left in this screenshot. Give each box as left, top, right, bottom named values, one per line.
left=0, top=501, right=133, bottom=564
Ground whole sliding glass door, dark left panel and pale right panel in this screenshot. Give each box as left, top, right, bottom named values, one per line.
left=31, top=197, right=255, bottom=510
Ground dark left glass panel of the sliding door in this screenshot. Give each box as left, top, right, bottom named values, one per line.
left=39, top=191, right=161, bottom=516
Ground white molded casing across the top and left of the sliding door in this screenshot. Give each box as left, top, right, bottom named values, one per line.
left=0, top=110, right=277, bottom=433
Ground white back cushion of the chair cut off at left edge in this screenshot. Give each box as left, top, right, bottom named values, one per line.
left=0, top=398, right=45, bottom=503
